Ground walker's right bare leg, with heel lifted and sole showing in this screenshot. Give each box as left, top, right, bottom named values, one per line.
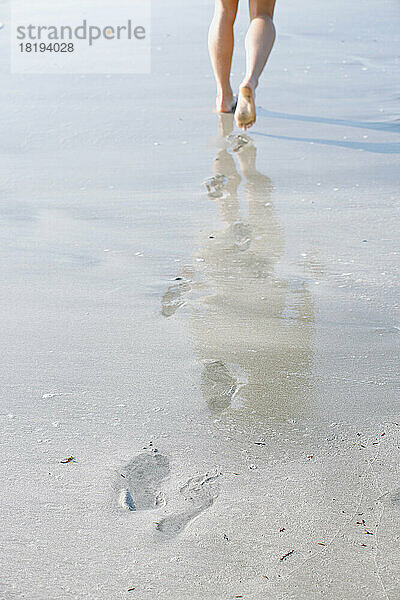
left=235, top=0, right=275, bottom=129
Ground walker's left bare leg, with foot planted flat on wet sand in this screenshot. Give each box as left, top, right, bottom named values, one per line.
left=208, top=0, right=239, bottom=112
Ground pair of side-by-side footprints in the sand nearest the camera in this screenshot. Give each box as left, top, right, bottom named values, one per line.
left=115, top=448, right=220, bottom=537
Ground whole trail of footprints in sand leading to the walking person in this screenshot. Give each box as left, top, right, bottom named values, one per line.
left=116, top=135, right=251, bottom=537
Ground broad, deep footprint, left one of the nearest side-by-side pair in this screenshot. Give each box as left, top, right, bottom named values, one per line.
left=116, top=450, right=170, bottom=511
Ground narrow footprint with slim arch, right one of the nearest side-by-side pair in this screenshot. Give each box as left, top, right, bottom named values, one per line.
left=156, top=472, right=220, bottom=537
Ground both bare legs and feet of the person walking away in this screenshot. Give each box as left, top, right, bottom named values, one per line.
left=208, top=0, right=275, bottom=130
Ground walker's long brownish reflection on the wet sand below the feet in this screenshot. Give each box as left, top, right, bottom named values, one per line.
left=162, top=115, right=314, bottom=418
